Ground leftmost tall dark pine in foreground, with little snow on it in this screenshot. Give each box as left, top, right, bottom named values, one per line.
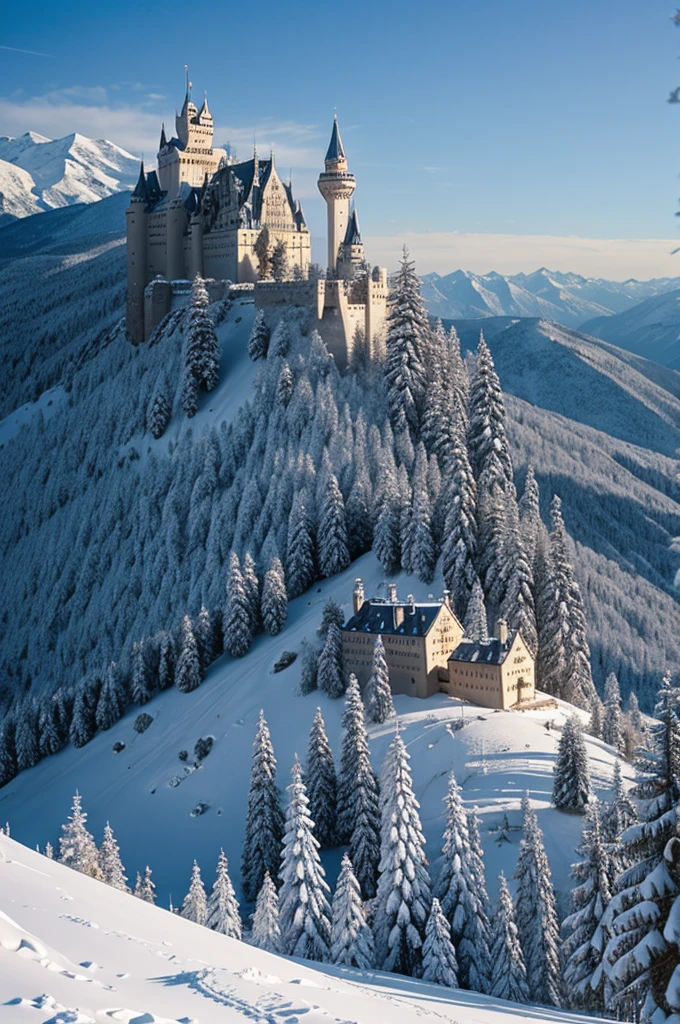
left=241, top=712, right=284, bottom=902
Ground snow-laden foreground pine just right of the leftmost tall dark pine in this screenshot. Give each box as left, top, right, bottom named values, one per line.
left=279, top=758, right=331, bottom=963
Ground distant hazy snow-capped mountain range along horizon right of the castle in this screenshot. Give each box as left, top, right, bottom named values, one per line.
left=423, top=267, right=680, bottom=327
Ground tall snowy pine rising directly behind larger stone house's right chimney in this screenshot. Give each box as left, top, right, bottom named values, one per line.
left=439, top=434, right=483, bottom=618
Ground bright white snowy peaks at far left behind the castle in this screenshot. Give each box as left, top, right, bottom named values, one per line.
left=0, top=132, right=139, bottom=224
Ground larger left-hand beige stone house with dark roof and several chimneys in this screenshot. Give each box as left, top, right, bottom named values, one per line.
left=342, top=580, right=463, bottom=697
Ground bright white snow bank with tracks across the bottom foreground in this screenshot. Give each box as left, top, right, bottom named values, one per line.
left=0, top=837, right=606, bottom=1024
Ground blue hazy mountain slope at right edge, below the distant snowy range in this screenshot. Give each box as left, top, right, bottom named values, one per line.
left=582, top=290, right=680, bottom=370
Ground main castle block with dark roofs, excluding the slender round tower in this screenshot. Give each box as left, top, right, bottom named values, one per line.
left=126, top=74, right=311, bottom=344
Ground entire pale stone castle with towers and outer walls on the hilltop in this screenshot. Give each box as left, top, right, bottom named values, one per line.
left=126, top=72, right=387, bottom=368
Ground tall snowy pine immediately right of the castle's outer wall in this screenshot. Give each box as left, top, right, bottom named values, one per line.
left=385, top=247, right=429, bottom=437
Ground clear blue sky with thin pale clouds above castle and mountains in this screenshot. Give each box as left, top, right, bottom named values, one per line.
left=0, top=0, right=680, bottom=278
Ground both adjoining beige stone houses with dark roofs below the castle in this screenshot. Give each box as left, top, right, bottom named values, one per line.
left=342, top=580, right=536, bottom=710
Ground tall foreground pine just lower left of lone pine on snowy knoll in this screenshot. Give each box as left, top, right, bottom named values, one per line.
left=514, top=796, right=562, bottom=1007
